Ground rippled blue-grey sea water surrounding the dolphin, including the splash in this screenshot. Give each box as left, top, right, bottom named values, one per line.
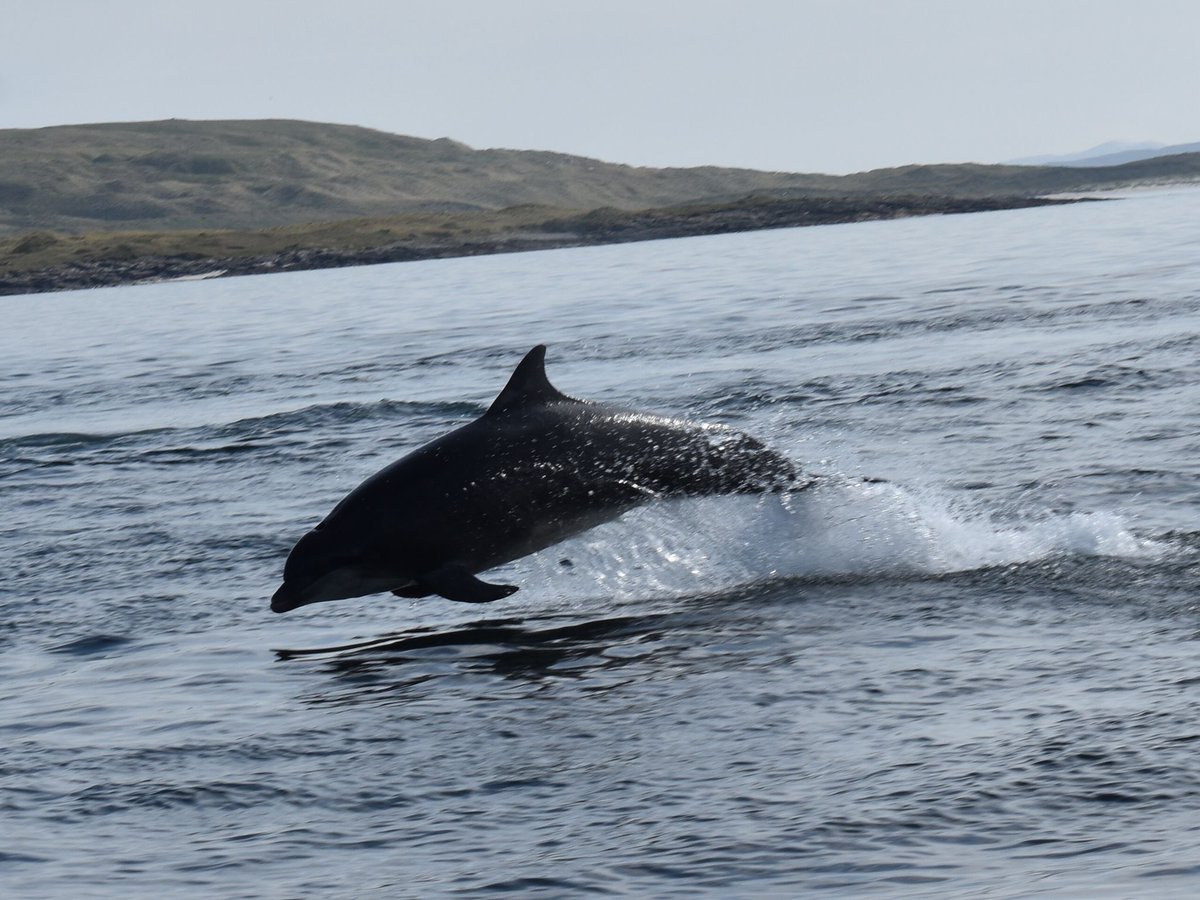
left=0, top=188, right=1200, bottom=898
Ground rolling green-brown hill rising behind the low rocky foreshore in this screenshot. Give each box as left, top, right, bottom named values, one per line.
left=0, top=119, right=1200, bottom=234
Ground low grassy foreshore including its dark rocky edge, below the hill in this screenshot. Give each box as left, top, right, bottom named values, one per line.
left=0, top=196, right=1069, bottom=295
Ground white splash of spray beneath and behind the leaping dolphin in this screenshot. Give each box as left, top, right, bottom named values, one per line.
left=518, top=480, right=1164, bottom=596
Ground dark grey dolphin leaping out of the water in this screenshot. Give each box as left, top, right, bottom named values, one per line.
left=271, top=346, right=806, bottom=612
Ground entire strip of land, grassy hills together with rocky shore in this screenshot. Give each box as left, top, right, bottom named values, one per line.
left=0, top=120, right=1200, bottom=294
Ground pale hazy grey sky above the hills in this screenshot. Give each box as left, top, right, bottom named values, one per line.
left=9, top=0, right=1200, bottom=172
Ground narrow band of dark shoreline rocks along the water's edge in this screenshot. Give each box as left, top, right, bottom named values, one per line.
left=0, top=196, right=1081, bottom=295
